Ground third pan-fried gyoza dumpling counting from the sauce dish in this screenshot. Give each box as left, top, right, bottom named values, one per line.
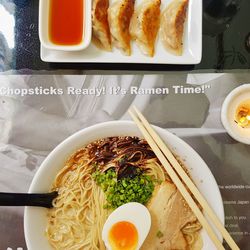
left=130, top=0, right=161, bottom=56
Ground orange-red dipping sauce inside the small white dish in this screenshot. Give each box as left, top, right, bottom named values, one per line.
left=49, top=0, right=84, bottom=45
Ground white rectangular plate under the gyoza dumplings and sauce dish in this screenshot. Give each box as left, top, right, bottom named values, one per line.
left=41, top=0, right=202, bottom=64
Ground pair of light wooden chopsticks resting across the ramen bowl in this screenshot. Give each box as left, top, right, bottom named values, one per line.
left=128, top=107, right=240, bottom=250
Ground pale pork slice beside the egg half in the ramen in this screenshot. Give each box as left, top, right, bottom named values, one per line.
left=141, top=182, right=196, bottom=250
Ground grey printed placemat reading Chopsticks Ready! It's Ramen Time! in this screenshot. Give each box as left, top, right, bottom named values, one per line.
left=0, top=73, right=250, bottom=250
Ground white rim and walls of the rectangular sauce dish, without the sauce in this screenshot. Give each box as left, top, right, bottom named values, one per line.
left=39, top=0, right=92, bottom=51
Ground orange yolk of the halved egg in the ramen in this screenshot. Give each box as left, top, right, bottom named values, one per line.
left=108, top=221, right=138, bottom=250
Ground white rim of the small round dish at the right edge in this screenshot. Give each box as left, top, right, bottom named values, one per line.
left=221, top=84, right=250, bottom=145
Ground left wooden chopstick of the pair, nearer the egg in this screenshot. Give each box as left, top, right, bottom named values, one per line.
left=128, top=107, right=225, bottom=250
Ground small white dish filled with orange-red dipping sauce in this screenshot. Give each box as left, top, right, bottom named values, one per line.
left=39, top=0, right=92, bottom=51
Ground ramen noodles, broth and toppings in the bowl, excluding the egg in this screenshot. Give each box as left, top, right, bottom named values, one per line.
left=46, top=136, right=202, bottom=250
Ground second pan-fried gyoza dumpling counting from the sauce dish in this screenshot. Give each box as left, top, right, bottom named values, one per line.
left=108, top=0, right=135, bottom=56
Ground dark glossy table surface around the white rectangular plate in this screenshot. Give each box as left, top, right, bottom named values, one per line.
left=0, top=0, right=250, bottom=72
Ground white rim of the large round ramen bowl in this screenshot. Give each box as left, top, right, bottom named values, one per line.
left=24, top=121, right=224, bottom=250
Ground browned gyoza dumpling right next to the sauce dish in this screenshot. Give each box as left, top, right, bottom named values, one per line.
left=92, top=0, right=112, bottom=51
